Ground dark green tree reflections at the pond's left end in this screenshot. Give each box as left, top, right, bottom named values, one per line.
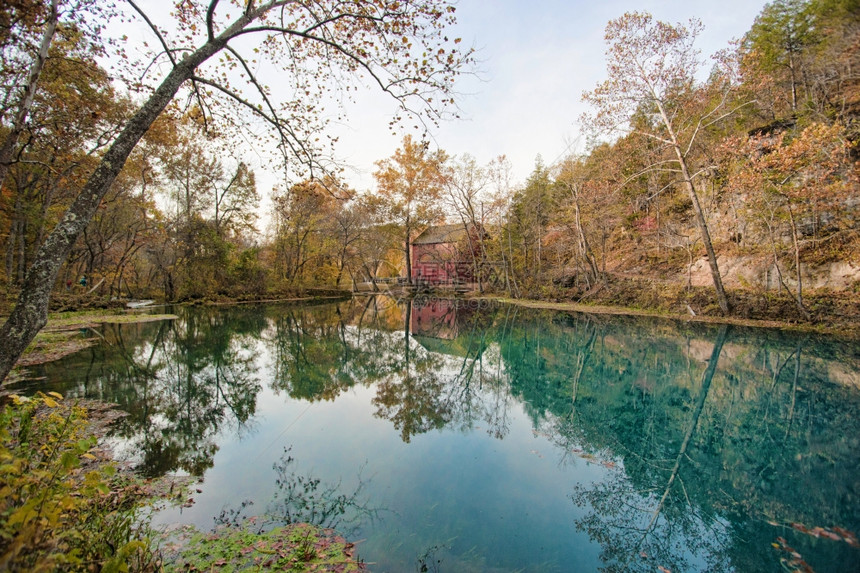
left=23, top=307, right=266, bottom=477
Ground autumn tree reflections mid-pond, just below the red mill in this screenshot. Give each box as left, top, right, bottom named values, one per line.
left=271, top=298, right=505, bottom=442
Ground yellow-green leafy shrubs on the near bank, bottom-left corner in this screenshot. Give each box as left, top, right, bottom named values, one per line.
left=0, top=392, right=154, bottom=572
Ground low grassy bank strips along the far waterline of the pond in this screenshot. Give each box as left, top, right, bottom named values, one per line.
left=7, top=278, right=860, bottom=381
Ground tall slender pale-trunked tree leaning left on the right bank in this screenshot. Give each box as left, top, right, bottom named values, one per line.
left=583, top=12, right=737, bottom=314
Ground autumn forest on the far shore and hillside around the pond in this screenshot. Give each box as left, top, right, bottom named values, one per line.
left=0, top=0, right=860, bottom=342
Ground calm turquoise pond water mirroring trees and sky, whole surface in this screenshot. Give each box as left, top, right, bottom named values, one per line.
left=11, top=298, right=860, bottom=572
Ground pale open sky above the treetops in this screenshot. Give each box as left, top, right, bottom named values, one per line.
left=326, top=0, right=765, bottom=191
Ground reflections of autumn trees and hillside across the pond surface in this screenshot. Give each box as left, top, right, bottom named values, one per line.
left=20, top=297, right=860, bottom=571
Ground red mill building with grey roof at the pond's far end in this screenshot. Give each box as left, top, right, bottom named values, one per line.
left=412, top=224, right=481, bottom=284
